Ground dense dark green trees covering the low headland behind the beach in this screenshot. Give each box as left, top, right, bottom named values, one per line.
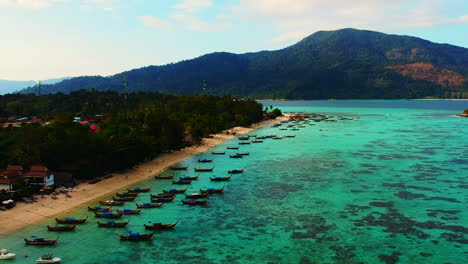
left=0, top=90, right=270, bottom=179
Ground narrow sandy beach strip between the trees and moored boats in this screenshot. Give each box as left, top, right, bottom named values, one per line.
left=0, top=117, right=287, bottom=235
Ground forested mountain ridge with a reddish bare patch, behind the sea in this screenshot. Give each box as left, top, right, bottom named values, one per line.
left=20, top=29, right=468, bottom=99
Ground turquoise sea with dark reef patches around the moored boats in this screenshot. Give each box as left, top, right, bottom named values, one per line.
left=0, top=101, right=468, bottom=264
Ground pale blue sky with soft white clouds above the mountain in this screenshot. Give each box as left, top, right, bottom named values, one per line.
left=0, top=0, right=468, bottom=80
